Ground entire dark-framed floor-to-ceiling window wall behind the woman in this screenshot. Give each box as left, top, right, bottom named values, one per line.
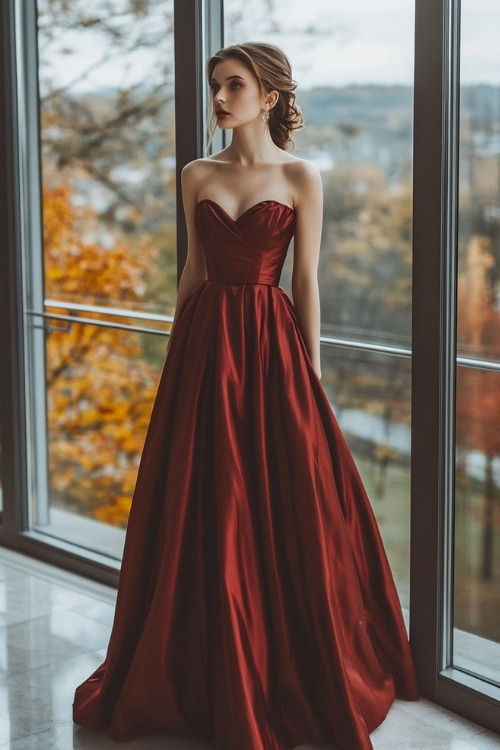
left=0, top=0, right=500, bottom=731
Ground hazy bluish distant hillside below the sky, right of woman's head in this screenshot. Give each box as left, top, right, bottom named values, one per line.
left=297, top=84, right=500, bottom=179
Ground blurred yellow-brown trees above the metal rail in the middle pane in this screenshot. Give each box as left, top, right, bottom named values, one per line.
left=320, top=164, right=412, bottom=344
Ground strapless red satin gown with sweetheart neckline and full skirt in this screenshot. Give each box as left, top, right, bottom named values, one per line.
left=74, top=200, right=417, bottom=750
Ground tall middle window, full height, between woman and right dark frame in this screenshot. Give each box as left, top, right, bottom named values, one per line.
left=224, top=0, right=414, bottom=606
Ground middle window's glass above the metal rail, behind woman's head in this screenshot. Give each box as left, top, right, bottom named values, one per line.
left=224, top=0, right=414, bottom=346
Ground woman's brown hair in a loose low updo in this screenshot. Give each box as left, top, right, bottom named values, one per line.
left=207, top=42, right=304, bottom=150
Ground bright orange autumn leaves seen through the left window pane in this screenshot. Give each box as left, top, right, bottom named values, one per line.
left=44, top=185, right=158, bottom=526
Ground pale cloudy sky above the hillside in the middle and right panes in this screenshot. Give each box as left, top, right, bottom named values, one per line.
left=225, top=0, right=500, bottom=87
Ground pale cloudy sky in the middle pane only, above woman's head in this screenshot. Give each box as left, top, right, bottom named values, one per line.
left=225, top=0, right=414, bottom=88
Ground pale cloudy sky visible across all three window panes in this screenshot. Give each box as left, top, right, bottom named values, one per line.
left=39, top=0, right=500, bottom=91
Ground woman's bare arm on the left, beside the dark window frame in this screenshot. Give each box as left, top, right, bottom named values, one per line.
left=167, top=162, right=207, bottom=350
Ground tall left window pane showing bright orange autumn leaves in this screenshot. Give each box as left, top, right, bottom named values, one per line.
left=31, top=0, right=177, bottom=558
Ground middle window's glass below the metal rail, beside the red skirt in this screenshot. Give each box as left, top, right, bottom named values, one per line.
left=321, top=347, right=411, bottom=607
